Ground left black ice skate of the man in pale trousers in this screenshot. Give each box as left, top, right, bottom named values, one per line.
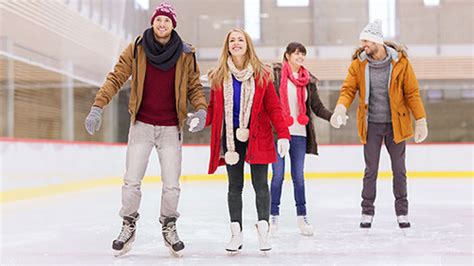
left=112, top=213, right=140, bottom=257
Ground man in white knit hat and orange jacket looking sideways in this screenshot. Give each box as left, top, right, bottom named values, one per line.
left=331, top=20, right=428, bottom=228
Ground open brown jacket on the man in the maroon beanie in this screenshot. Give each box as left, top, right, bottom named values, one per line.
left=94, top=37, right=207, bottom=128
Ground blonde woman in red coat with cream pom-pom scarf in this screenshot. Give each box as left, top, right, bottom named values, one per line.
left=206, top=29, right=290, bottom=255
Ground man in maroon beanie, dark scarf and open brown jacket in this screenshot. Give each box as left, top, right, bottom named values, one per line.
left=85, top=3, right=207, bottom=256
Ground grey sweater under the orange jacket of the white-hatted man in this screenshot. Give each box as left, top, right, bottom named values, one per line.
left=368, top=50, right=392, bottom=123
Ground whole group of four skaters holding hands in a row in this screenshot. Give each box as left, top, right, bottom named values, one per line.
left=85, top=2, right=428, bottom=256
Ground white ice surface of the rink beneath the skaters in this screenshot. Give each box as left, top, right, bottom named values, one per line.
left=0, top=178, right=473, bottom=265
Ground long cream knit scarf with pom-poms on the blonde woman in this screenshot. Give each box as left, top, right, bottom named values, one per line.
left=224, top=57, right=255, bottom=165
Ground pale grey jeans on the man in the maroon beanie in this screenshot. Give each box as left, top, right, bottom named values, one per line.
left=120, top=121, right=182, bottom=222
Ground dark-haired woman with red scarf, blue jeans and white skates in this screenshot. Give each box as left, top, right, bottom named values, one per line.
left=270, top=42, right=332, bottom=236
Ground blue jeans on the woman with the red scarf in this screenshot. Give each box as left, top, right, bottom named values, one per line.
left=270, top=136, right=306, bottom=216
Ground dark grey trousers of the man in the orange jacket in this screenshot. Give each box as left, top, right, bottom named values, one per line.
left=361, top=122, right=408, bottom=216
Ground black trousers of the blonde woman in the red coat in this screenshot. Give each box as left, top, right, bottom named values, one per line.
left=226, top=135, right=270, bottom=228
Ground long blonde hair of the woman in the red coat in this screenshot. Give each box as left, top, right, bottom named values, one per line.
left=208, top=28, right=273, bottom=89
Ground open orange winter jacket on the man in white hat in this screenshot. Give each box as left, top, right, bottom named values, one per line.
left=337, top=42, right=426, bottom=144
